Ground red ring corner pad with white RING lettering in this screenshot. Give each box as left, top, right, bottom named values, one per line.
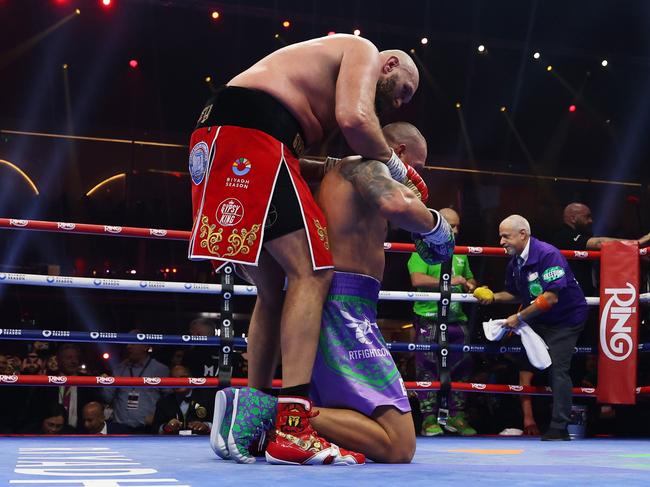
left=597, top=241, right=639, bottom=404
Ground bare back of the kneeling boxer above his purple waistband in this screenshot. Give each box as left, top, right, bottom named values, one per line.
left=316, top=158, right=388, bottom=281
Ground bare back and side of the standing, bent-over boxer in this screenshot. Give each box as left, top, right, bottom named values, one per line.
left=228, top=35, right=370, bottom=145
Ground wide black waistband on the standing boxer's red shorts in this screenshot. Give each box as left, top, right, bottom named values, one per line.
left=196, top=86, right=305, bottom=157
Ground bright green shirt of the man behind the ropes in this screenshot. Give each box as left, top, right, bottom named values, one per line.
left=408, top=252, right=474, bottom=323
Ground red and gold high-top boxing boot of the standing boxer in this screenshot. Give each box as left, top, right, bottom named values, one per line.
left=266, top=396, right=366, bottom=465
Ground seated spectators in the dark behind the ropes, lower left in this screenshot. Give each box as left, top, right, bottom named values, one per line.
left=0, top=318, right=246, bottom=434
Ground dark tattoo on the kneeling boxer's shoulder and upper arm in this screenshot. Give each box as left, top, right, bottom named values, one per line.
left=340, top=160, right=403, bottom=205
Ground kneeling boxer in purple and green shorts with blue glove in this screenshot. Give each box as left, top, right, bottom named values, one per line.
left=298, top=122, right=454, bottom=463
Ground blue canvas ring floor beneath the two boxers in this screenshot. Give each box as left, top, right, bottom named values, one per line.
left=0, top=436, right=650, bottom=487
